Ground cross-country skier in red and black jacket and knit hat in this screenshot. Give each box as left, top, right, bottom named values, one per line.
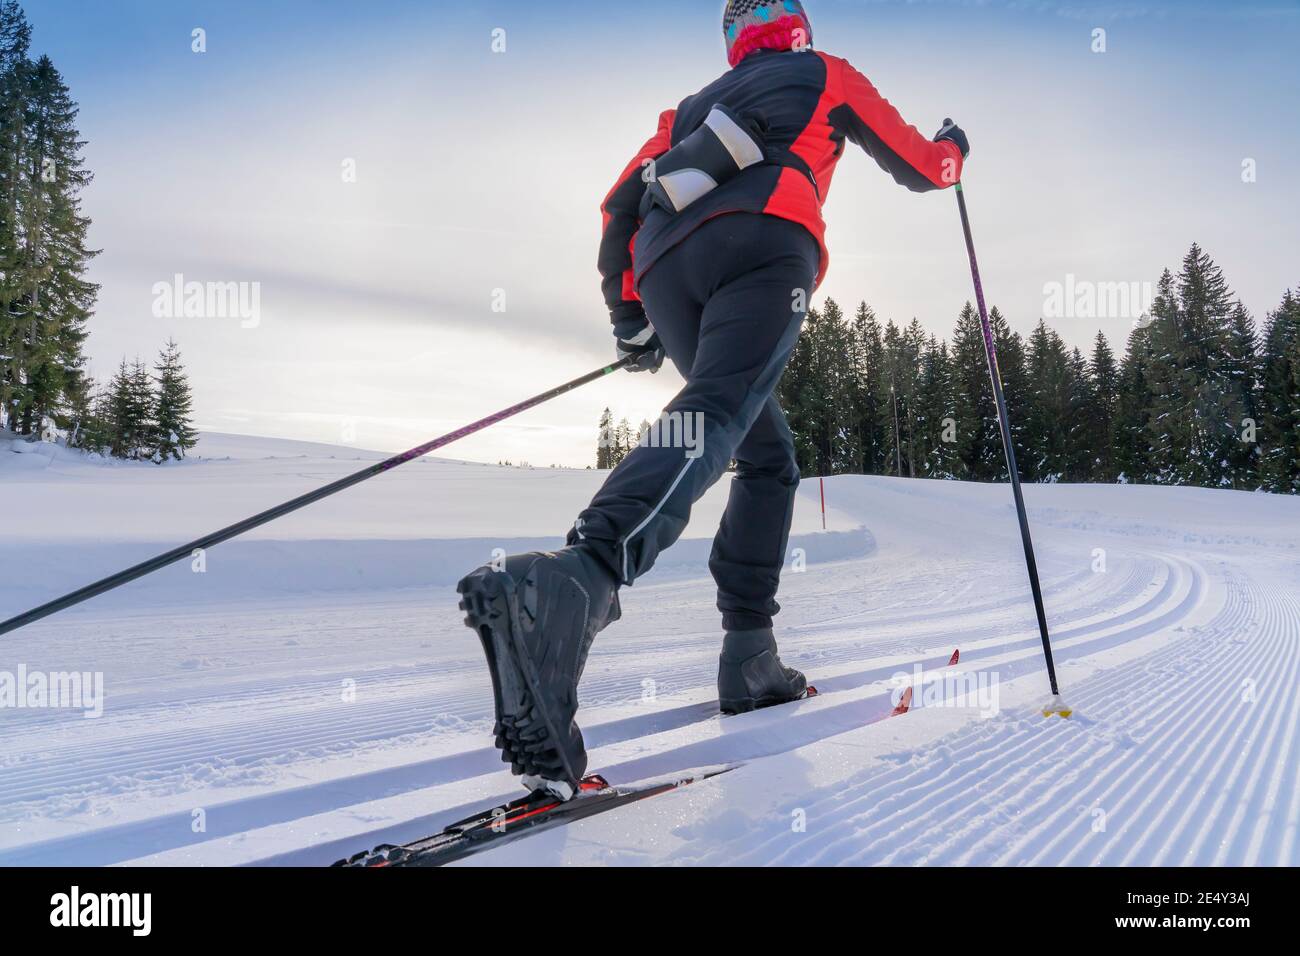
left=458, top=0, right=969, bottom=799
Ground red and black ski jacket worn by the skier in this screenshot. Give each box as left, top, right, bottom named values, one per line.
left=598, top=51, right=962, bottom=329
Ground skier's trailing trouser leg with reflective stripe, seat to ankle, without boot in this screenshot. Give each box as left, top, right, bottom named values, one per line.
left=569, top=213, right=818, bottom=584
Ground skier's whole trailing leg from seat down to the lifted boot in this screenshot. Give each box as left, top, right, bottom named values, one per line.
left=458, top=215, right=818, bottom=796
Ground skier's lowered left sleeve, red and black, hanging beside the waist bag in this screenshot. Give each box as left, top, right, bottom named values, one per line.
left=597, top=109, right=677, bottom=329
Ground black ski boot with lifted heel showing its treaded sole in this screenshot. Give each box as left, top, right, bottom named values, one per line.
left=456, top=545, right=620, bottom=800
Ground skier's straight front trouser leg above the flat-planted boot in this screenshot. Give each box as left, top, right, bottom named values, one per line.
left=709, top=395, right=800, bottom=631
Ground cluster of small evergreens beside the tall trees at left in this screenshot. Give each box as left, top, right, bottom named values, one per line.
left=69, top=341, right=199, bottom=463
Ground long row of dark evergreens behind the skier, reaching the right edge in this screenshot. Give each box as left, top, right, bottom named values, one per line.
left=597, top=245, right=1300, bottom=493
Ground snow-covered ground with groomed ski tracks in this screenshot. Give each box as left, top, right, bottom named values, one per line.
left=0, top=436, right=1300, bottom=865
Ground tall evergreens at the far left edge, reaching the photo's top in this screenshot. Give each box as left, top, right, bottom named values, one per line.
left=0, top=0, right=98, bottom=434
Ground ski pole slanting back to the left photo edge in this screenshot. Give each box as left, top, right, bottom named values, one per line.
left=0, top=355, right=636, bottom=635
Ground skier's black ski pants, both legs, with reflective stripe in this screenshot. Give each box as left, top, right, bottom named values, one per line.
left=569, top=213, right=820, bottom=631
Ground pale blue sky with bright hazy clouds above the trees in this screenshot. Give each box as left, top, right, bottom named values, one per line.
left=25, top=0, right=1300, bottom=464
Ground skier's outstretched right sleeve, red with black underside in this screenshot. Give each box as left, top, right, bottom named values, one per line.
left=829, top=60, right=963, bottom=193
